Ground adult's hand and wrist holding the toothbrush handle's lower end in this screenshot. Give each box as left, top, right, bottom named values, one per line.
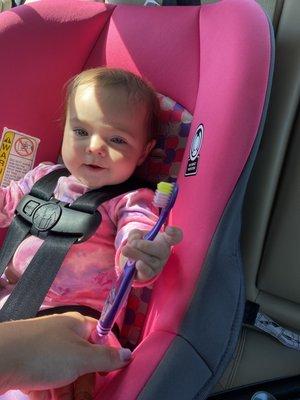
left=0, top=312, right=131, bottom=393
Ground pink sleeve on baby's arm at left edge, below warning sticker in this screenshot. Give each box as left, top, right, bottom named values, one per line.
left=0, top=164, right=61, bottom=228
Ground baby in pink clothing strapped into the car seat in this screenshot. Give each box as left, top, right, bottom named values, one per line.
left=0, top=68, right=181, bottom=311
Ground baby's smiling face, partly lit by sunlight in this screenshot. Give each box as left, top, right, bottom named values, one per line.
left=62, top=85, right=154, bottom=189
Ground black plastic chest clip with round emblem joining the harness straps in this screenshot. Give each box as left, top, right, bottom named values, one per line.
left=16, top=194, right=101, bottom=243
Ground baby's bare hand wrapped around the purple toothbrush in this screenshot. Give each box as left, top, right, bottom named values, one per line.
left=121, top=226, right=182, bottom=282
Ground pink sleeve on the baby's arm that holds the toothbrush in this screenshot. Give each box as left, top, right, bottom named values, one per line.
left=110, top=189, right=158, bottom=286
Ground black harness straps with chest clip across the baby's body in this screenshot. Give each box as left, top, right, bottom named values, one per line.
left=0, top=169, right=153, bottom=322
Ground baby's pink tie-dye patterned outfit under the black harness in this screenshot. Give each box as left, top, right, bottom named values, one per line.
left=0, top=164, right=157, bottom=311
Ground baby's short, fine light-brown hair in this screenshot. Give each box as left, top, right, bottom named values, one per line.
left=66, top=67, right=160, bottom=139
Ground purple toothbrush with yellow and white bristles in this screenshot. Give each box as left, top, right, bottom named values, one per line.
left=92, top=182, right=178, bottom=344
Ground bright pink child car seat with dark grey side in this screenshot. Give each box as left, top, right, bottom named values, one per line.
left=0, top=0, right=273, bottom=400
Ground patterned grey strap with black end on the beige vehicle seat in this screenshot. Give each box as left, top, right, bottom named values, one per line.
left=243, top=300, right=300, bottom=351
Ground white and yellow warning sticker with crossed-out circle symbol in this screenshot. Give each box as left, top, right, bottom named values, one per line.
left=0, top=128, right=40, bottom=186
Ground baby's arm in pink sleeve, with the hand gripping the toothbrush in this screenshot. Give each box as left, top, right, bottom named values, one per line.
left=112, top=189, right=182, bottom=284
